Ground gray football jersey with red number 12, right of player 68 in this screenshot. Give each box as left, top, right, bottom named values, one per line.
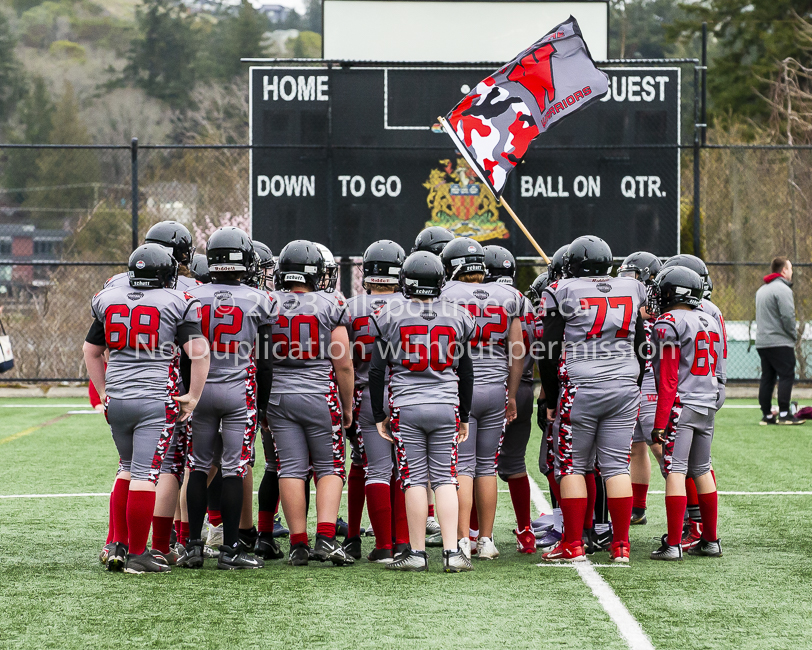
left=189, top=283, right=276, bottom=383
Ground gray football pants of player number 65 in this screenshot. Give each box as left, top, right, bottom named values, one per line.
left=663, top=406, right=716, bottom=478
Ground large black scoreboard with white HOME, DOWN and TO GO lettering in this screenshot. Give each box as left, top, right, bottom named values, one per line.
left=249, top=65, right=680, bottom=256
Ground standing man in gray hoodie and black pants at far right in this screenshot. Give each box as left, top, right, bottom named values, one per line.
left=756, top=257, right=804, bottom=424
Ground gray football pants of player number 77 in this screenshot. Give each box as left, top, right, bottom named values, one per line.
left=554, top=381, right=640, bottom=480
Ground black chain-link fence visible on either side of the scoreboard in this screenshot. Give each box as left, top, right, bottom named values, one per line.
left=0, top=145, right=812, bottom=382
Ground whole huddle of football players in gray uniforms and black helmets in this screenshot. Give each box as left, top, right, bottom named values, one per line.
left=84, top=221, right=727, bottom=573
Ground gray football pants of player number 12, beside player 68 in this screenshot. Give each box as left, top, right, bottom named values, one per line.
left=189, top=377, right=257, bottom=478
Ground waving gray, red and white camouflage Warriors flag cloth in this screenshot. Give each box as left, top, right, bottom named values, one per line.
left=440, top=16, right=609, bottom=198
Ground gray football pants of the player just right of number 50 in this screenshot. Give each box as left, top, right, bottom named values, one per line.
left=457, top=384, right=507, bottom=478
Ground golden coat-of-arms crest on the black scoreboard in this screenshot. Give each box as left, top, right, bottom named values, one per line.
left=423, top=156, right=509, bottom=241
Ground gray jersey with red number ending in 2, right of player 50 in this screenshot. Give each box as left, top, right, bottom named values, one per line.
left=443, top=280, right=524, bottom=384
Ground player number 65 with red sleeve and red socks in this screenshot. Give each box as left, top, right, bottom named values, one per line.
left=650, top=266, right=722, bottom=560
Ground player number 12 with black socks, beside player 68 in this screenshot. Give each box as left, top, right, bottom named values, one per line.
left=178, top=226, right=276, bottom=569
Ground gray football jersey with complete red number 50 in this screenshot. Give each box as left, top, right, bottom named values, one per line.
left=372, top=297, right=476, bottom=407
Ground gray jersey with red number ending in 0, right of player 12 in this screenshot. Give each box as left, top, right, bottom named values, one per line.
left=271, top=291, right=350, bottom=395
